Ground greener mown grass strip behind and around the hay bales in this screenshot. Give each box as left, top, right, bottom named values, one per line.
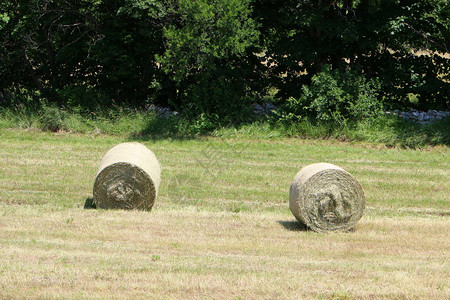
left=0, top=130, right=450, bottom=211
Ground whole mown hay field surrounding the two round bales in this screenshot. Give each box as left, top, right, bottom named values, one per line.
left=0, top=129, right=450, bottom=299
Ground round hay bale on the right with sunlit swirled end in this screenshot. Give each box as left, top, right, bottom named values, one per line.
left=289, top=163, right=365, bottom=232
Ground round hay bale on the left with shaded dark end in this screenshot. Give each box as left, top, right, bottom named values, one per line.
left=94, top=143, right=161, bottom=210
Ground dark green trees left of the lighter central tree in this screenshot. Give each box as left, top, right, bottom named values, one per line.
left=0, top=0, right=167, bottom=107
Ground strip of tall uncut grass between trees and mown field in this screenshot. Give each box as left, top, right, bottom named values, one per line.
left=0, top=106, right=450, bottom=148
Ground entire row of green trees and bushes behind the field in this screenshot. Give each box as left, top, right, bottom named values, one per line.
left=0, top=0, right=450, bottom=121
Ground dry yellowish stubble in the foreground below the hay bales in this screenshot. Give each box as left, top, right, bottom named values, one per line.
left=0, top=206, right=450, bottom=299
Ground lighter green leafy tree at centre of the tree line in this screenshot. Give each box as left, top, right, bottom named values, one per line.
left=157, top=0, right=259, bottom=122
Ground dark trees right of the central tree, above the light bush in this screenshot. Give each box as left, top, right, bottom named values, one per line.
left=255, top=0, right=450, bottom=109
